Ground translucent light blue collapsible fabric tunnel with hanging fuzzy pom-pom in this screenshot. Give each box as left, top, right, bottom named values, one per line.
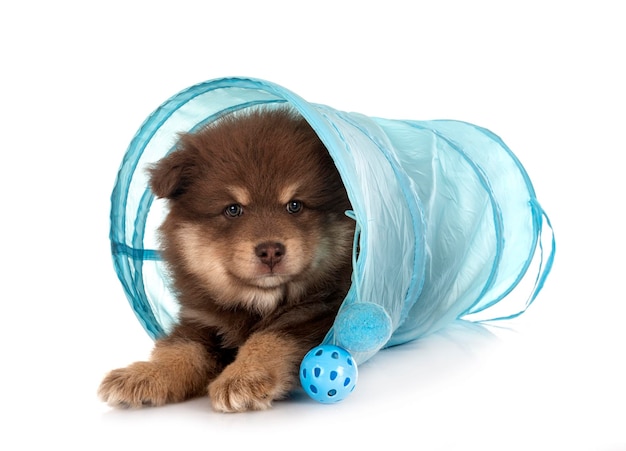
left=110, top=78, right=555, bottom=363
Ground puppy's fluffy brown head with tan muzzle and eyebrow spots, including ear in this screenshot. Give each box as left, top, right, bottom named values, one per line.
left=146, top=110, right=354, bottom=313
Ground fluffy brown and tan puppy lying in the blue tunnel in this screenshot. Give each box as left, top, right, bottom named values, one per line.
left=98, top=108, right=355, bottom=412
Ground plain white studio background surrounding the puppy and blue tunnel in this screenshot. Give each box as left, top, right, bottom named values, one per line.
left=0, top=0, right=626, bottom=451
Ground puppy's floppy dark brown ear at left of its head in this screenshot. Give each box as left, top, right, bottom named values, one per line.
left=148, top=136, right=197, bottom=199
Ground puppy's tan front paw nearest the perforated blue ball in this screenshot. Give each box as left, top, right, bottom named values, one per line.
left=209, top=362, right=288, bottom=412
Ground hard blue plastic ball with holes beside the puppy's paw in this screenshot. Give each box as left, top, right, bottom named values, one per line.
left=300, top=345, right=358, bottom=404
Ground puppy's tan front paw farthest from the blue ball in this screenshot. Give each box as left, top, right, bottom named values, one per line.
left=98, top=362, right=169, bottom=408
